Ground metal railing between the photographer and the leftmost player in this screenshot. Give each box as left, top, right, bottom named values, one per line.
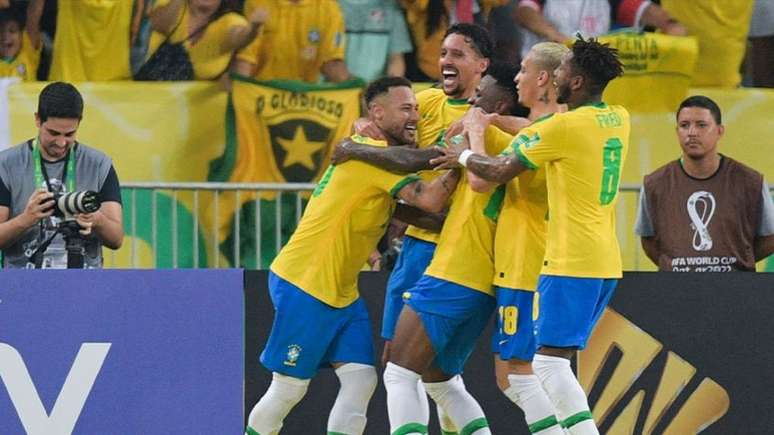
left=115, top=182, right=317, bottom=268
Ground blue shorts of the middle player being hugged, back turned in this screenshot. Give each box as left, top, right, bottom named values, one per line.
left=403, top=275, right=495, bottom=375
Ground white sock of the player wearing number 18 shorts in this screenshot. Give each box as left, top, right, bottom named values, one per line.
left=503, top=374, right=564, bottom=435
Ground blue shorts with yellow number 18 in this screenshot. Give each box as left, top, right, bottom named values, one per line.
left=492, top=287, right=538, bottom=361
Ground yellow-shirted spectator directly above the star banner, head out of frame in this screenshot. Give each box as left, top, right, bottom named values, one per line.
left=234, top=0, right=352, bottom=83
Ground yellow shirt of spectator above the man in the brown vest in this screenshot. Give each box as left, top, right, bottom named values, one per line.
left=654, top=0, right=756, bottom=87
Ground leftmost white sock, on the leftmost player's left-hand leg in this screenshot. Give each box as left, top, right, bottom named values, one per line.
left=247, top=373, right=309, bottom=435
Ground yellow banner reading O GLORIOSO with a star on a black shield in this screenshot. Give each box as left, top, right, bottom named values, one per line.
left=206, top=77, right=363, bottom=267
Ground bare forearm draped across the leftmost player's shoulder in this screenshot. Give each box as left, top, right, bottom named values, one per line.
left=331, top=138, right=439, bottom=173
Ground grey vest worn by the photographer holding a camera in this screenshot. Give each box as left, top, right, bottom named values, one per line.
left=0, top=140, right=113, bottom=268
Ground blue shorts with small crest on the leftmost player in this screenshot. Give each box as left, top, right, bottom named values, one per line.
left=261, top=272, right=374, bottom=379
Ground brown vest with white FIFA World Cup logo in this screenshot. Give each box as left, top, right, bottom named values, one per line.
left=645, top=156, right=763, bottom=272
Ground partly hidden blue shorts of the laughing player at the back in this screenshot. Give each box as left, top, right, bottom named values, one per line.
left=382, top=236, right=436, bottom=340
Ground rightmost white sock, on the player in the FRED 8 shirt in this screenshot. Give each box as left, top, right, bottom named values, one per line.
left=532, top=354, right=599, bottom=435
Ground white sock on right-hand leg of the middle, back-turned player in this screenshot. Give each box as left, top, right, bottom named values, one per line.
left=425, top=375, right=491, bottom=435
